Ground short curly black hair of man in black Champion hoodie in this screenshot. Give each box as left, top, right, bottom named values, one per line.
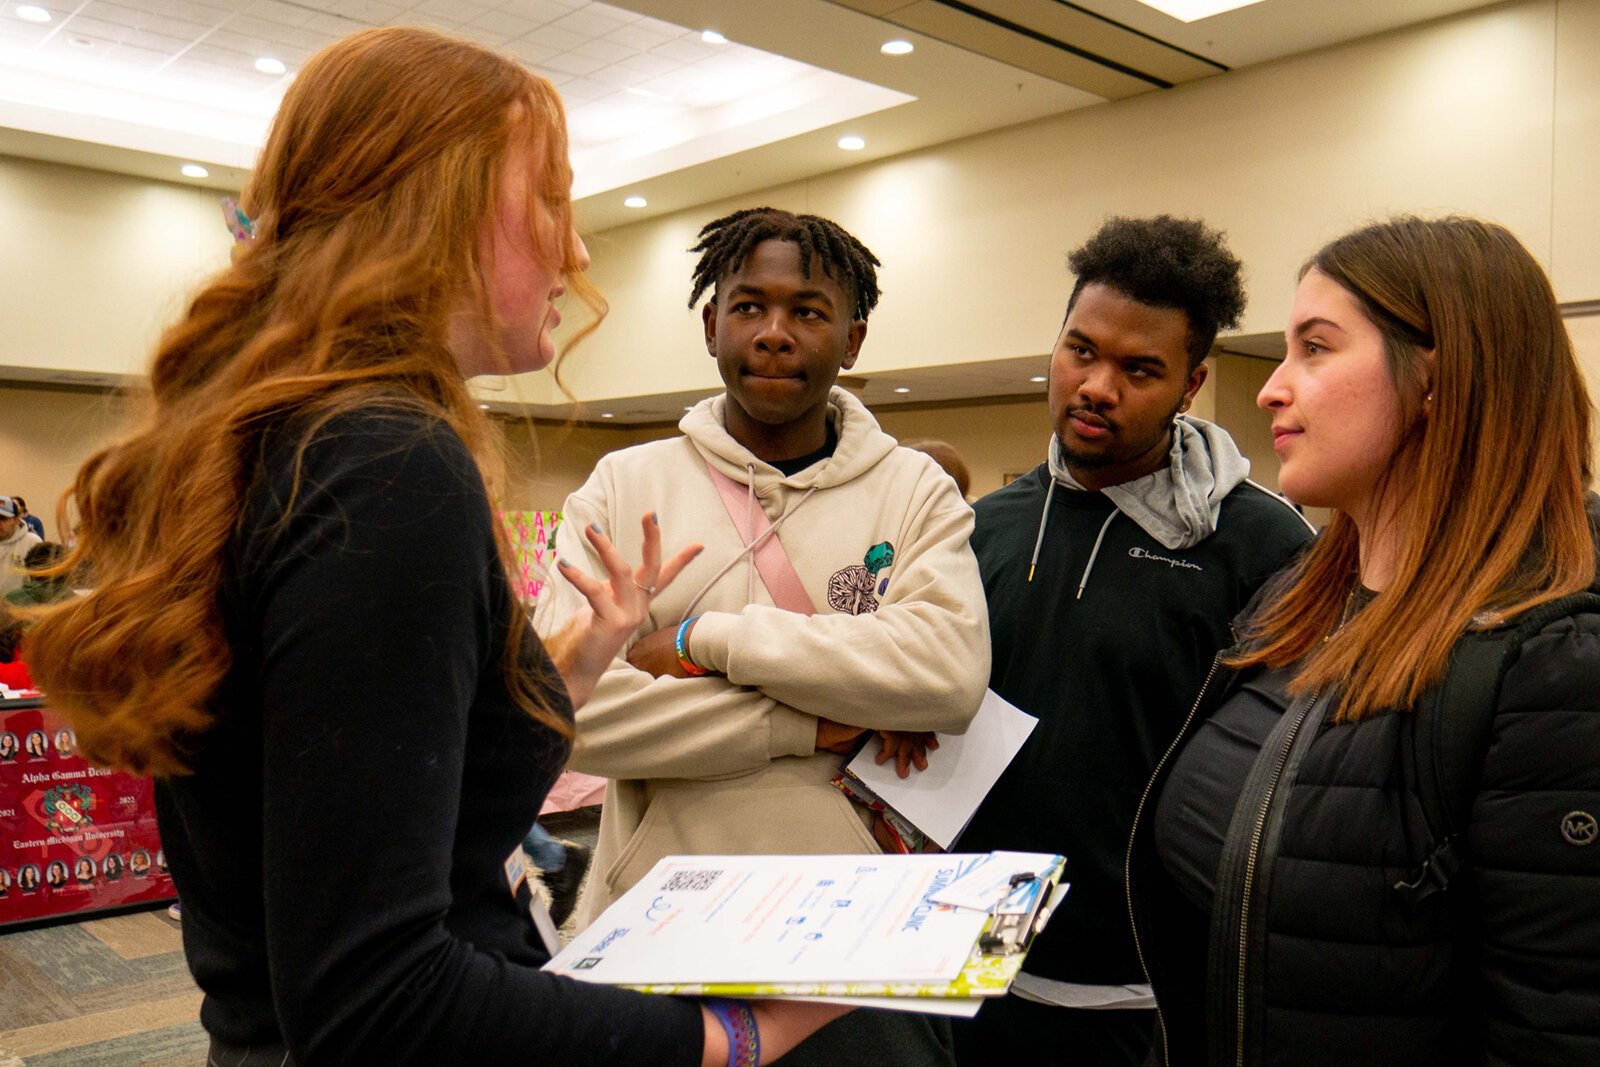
left=1067, top=214, right=1245, bottom=370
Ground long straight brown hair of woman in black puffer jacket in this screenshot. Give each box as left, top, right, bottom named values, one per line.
left=1232, top=218, right=1595, bottom=721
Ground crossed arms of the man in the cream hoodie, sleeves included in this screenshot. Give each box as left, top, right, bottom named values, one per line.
left=538, top=479, right=989, bottom=779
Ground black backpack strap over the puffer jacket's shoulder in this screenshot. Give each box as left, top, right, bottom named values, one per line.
left=1394, top=593, right=1600, bottom=904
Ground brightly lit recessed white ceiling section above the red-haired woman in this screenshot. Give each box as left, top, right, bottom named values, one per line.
left=0, top=0, right=912, bottom=195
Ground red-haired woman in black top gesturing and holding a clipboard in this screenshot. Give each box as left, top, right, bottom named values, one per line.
left=30, top=29, right=838, bottom=1067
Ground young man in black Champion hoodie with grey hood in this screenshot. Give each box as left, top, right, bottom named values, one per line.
left=957, top=216, right=1312, bottom=1065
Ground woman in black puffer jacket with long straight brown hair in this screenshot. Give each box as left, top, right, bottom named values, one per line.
left=1128, top=219, right=1600, bottom=1067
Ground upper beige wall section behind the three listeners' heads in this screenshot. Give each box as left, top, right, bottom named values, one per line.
left=571, top=0, right=1600, bottom=398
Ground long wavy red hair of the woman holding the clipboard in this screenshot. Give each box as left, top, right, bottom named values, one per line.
left=29, top=27, right=603, bottom=774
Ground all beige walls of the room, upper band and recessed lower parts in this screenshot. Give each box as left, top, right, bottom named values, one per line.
left=0, top=0, right=1600, bottom=526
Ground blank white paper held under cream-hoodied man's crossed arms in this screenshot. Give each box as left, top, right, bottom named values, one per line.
left=848, top=689, right=1038, bottom=848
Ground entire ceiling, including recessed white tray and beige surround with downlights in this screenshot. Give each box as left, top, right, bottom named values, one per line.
left=0, top=0, right=1488, bottom=239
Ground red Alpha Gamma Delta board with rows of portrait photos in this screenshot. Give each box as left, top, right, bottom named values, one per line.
left=0, top=701, right=178, bottom=926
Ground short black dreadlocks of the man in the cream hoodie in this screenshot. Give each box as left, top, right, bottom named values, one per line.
left=690, top=208, right=880, bottom=322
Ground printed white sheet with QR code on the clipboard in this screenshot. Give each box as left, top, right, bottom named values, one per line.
left=546, top=854, right=987, bottom=995
